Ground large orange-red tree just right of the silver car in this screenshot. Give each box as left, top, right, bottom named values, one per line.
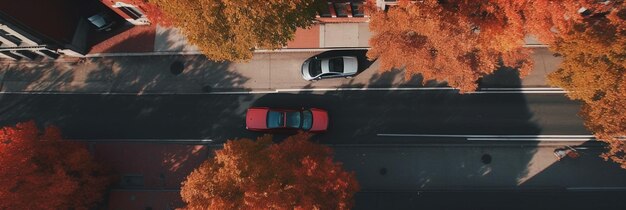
left=367, top=0, right=532, bottom=92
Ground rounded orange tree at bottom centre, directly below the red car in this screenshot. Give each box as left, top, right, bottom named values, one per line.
left=181, top=134, right=359, bottom=209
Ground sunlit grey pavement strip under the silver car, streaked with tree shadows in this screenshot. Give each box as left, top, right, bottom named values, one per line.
left=0, top=48, right=560, bottom=94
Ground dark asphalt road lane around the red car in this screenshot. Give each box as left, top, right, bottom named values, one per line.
left=0, top=90, right=589, bottom=144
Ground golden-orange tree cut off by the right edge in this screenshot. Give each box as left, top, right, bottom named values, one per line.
left=549, top=1, right=626, bottom=169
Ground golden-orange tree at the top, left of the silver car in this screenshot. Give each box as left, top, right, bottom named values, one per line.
left=150, top=0, right=324, bottom=61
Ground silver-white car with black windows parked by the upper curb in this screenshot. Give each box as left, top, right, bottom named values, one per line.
left=302, top=56, right=358, bottom=81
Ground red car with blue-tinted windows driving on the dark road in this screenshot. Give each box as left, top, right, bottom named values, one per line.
left=246, top=107, right=328, bottom=132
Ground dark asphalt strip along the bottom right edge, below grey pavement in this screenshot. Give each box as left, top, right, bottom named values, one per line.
left=354, top=190, right=626, bottom=210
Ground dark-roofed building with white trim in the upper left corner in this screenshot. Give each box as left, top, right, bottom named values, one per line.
left=0, top=0, right=150, bottom=60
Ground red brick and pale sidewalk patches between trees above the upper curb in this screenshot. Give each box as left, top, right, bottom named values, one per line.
left=87, top=22, right=545, bottom=57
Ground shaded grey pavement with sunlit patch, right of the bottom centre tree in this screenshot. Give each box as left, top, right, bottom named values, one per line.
left=334, top=144, right=626, bottom=192
